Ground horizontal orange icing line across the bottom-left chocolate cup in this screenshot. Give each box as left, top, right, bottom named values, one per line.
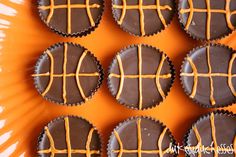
left=38, top=149, right=100, bottom=154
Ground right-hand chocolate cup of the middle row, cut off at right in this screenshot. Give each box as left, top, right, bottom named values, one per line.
left=180, top=44, right=236, bottom=108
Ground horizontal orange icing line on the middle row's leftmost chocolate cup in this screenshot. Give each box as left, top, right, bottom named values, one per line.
left=32, top=72, right=99, bottom=77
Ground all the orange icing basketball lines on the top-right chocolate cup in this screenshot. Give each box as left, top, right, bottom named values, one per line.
left=180, top=0, right=236, bottom=40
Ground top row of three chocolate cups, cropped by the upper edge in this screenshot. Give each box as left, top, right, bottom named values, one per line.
left=38, top=0, right=236, bottom=40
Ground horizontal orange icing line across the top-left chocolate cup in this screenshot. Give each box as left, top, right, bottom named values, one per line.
left=38, top=4, right=100, bottom=10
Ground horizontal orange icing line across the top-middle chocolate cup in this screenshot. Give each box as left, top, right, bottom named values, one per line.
left=113, top=5, right=172, bottom=10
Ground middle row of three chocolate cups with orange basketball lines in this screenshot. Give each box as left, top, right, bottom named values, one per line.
left=33, top=43, right=236, bottom=110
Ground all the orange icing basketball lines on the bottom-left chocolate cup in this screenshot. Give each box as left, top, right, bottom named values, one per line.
left=38, top=117, right=100, bottom=157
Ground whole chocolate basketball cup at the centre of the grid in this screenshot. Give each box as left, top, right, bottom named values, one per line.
left=108, top=44, right=174, bottom=110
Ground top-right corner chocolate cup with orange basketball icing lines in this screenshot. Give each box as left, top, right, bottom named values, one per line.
left=179, top=0, right=236, bottom=40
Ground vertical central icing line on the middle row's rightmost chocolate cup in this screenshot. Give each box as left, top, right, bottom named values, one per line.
left=207, top=46, right=216, bottom=105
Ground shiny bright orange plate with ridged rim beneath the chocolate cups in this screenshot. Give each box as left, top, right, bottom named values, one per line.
left=0, top=0, right=236, bottom=157
